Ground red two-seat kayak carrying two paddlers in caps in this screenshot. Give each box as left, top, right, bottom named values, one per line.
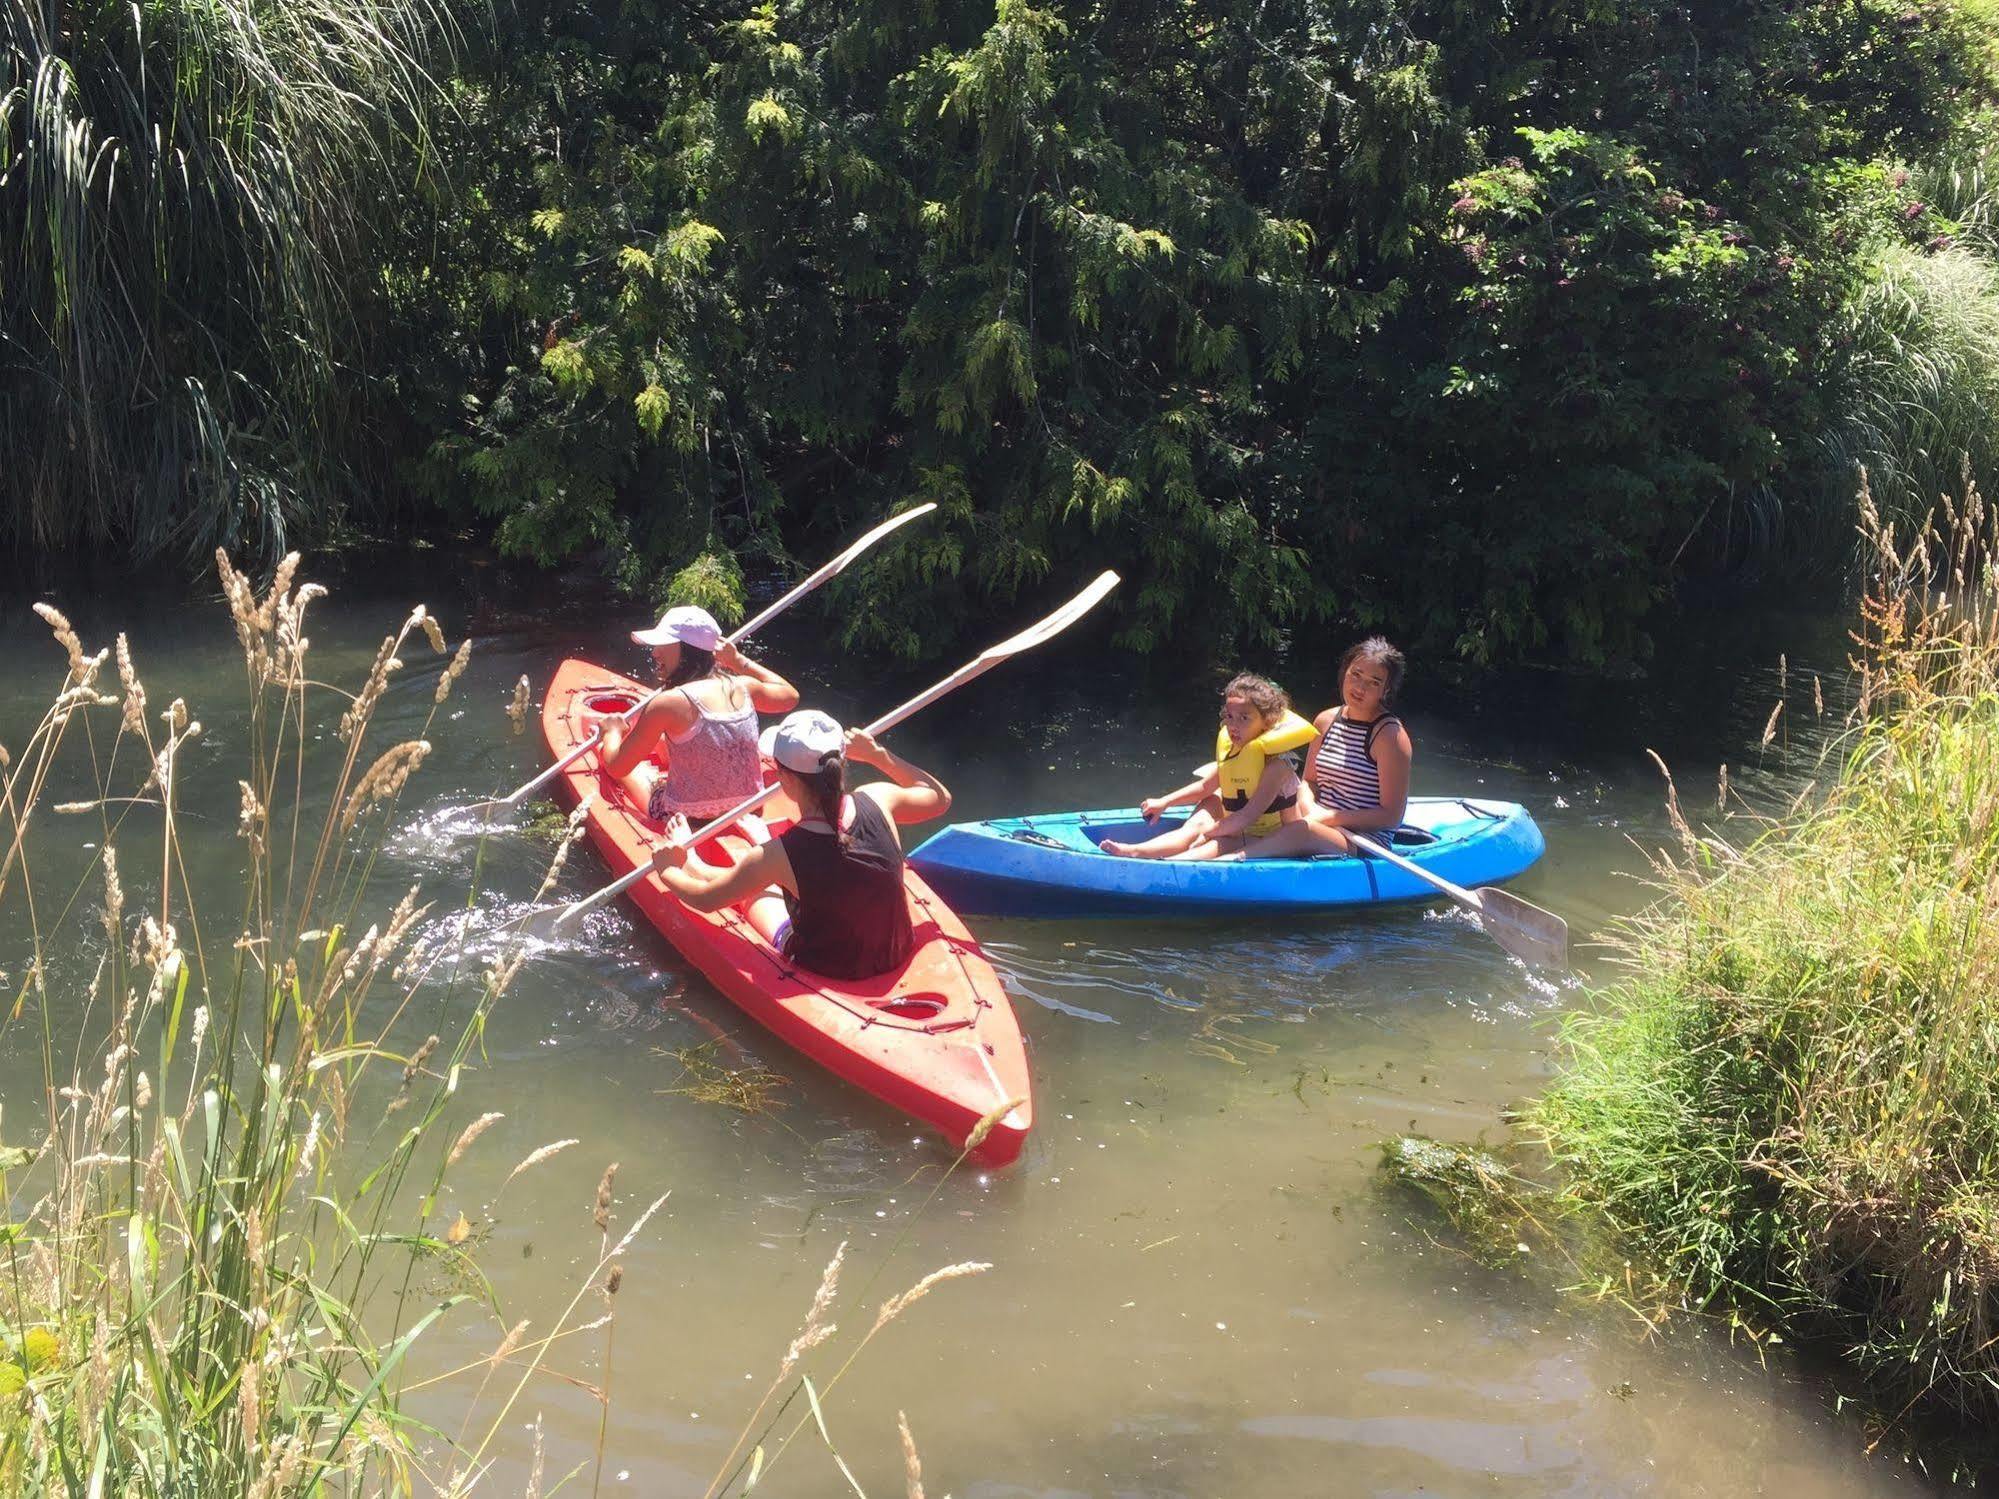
left=542, top=658, right=1033, bottom=1165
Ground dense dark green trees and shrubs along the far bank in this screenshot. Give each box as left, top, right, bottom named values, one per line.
left=6, top=0, right=1999, bottom=660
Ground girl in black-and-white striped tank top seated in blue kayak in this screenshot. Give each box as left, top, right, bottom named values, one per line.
left=1243, top=636, right=1415, bottom=859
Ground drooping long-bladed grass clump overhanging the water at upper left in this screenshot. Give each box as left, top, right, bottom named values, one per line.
left=0, top=0, right=450, bottom=560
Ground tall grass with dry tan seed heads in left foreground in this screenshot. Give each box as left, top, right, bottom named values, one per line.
left=0, top=556, right=1011, bottom=1499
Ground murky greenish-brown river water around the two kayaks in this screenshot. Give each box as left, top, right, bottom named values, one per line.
left=0, top=564, right=1915, bottom=1499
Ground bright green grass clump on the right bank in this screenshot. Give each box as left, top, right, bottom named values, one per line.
left=1527, top=481, right=1999, bottom=1417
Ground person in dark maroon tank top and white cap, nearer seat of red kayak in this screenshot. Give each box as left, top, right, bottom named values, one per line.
left=652, top=708, right=952, bottom=979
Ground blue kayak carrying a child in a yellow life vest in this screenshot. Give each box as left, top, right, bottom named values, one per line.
left=910, top=797, right=1547, bottom=915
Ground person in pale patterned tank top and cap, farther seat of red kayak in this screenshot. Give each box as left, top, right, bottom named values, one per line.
left=602, top=604, right=798, bottom=823
